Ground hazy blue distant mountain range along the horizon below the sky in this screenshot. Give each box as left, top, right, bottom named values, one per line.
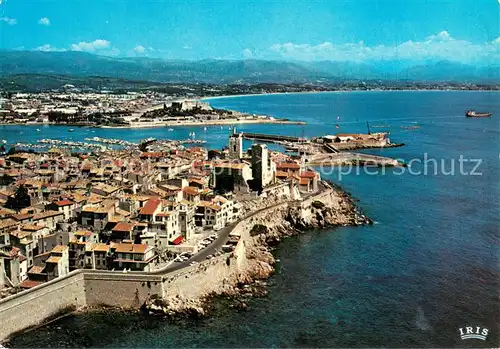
left=0, top=51, right=500, bottom=84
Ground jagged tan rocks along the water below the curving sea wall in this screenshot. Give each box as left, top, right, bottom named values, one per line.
left=141, top=183, right=373, bottom=319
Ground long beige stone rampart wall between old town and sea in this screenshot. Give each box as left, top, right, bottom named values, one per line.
left=0, top=189, right=336, bottom=341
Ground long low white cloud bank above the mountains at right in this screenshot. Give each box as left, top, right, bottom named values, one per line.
left=268, top=30, right=500, bottom=63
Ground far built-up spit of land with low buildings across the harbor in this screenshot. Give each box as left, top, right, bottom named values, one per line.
left=0, top=91, right=304, bottom=128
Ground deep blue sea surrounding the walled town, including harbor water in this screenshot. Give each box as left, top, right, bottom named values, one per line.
left=0, top=91, right=500, bottom=348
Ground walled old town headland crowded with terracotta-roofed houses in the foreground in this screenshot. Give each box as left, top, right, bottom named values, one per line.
left=0, top=118, right=398, bottom=341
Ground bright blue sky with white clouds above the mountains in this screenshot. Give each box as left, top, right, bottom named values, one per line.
left=0, top=0, right=500, bottom=65
